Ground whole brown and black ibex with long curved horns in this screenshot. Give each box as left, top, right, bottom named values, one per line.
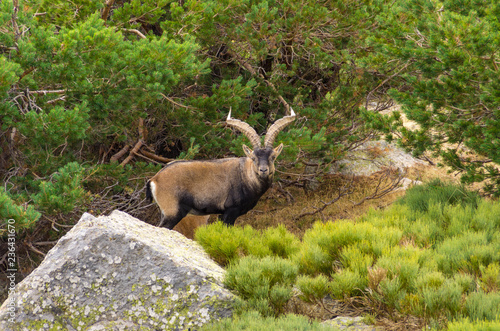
left=146, top=108, right=295, bottom=229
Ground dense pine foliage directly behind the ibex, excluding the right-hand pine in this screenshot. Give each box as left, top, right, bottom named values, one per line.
left=0, top=0, right=394, bottom=239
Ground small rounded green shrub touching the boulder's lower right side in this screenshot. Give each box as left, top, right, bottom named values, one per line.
left=224, top=256, right=298, bottom=316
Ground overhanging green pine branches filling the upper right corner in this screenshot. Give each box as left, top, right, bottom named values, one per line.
left=369, top=0, right=500, bottom=196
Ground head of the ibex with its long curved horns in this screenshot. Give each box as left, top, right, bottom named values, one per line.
left=226, top=108, right=295, bottom=180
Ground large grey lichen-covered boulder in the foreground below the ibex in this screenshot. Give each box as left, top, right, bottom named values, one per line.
left=0, top=211, right=234, bottom=330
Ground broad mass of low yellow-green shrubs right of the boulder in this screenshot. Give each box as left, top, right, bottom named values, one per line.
left=196, top=181, right=500, bottom=326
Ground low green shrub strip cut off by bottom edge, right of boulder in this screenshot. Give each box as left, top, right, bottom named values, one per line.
left=201, top=311, right=325, bottom=331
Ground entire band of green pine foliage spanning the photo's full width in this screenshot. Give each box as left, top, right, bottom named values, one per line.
left=0, top=0, right=500, bottom=236
